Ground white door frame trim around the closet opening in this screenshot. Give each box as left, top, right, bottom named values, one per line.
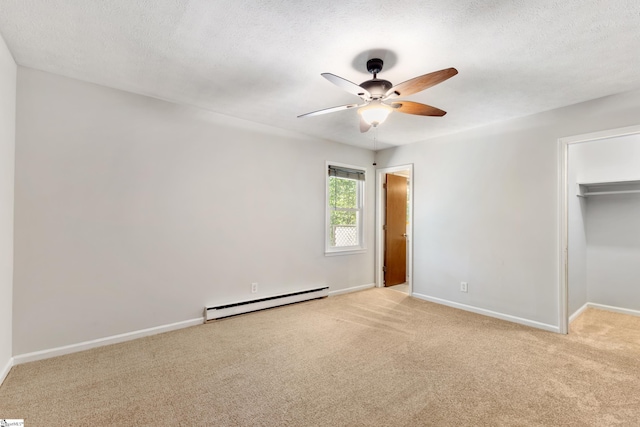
left=558, top=125, right=640, bottom=334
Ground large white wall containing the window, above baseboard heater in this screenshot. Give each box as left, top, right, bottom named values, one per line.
left=14, top=67, right=374, bottom=354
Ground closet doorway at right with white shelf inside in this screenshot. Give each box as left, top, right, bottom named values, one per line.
left=558, top=126, right=640, bottom=334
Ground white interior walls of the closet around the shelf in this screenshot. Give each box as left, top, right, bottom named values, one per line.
left=569, top=134, right=640, bottom=313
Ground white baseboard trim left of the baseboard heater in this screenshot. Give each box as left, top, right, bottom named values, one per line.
left=13, top=317, right=204, bottom=365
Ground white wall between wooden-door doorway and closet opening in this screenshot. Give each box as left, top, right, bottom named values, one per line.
left=376, top=86, right=640, bottom=329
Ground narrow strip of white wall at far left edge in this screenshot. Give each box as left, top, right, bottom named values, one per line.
left=0, top=32, right=17, bottom=383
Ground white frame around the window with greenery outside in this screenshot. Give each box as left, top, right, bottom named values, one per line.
left=324, top=161, right=367, bottom=256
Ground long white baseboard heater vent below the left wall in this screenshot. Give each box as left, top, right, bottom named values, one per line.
left=204, top=286, right=329, bottom=322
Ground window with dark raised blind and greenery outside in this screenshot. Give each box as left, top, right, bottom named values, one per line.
left=325, top=163, right=365, bottom=254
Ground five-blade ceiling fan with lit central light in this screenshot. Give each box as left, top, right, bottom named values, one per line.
left=298, top=58, right=458, bottom=132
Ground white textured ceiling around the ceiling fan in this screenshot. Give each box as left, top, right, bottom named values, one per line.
left=0, top=0, right=640, bottom=148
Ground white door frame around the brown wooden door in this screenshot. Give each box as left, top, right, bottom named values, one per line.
left=375, top=163, right=414, bottom=295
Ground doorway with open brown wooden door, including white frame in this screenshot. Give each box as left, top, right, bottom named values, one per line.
left=375, top=164, right=413, bottom=295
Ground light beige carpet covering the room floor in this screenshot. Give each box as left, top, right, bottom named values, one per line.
left=0, top=289, right=640, bottom=427
